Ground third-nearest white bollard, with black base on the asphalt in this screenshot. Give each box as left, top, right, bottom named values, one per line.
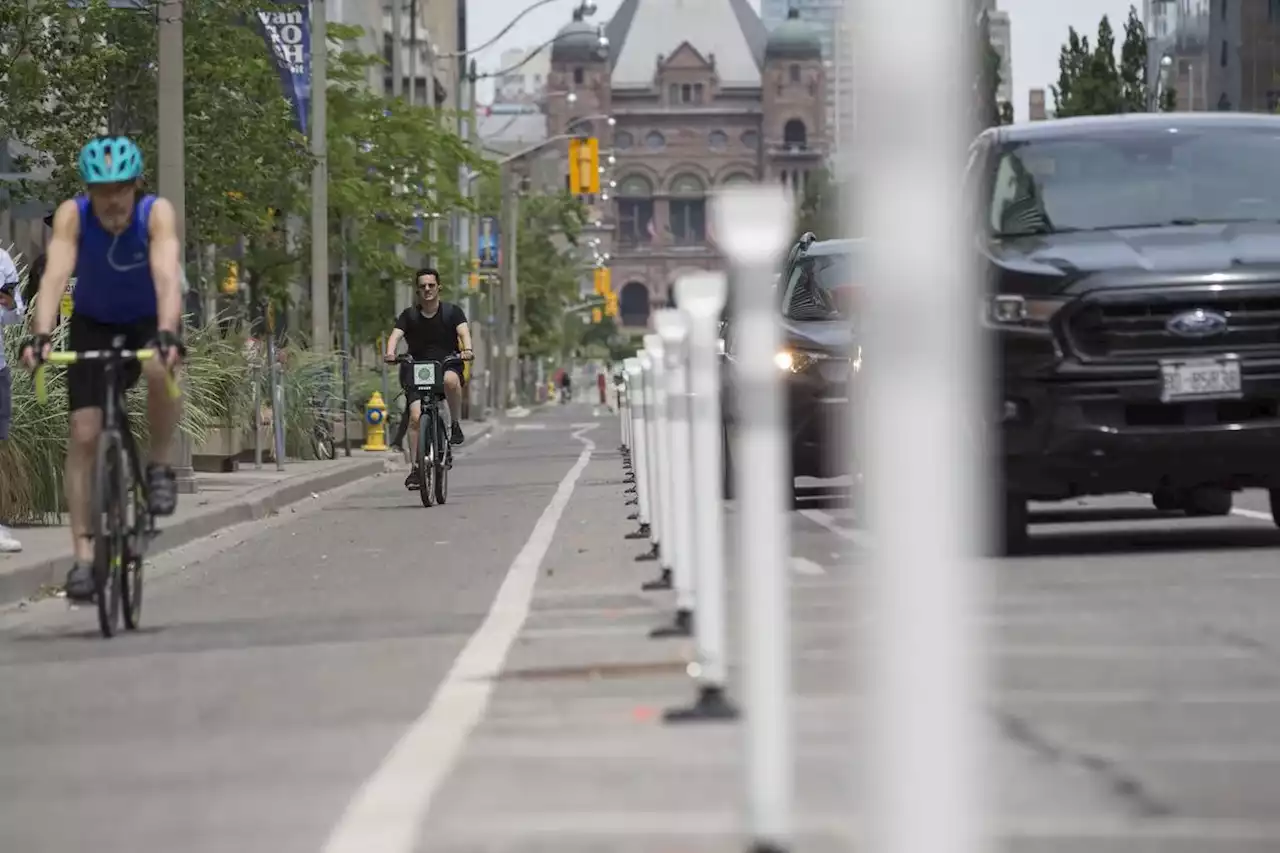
left=664, top=273, right=737, bottom=722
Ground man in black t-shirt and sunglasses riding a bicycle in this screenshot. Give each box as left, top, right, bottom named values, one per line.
left=385, top=269, right=475, bottom=489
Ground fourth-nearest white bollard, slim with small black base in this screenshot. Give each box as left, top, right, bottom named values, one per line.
left=649, top=309, right=695, bottom=638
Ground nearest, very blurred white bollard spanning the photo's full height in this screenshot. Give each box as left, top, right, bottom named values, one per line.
left=846, top=0, right=983, bottom=853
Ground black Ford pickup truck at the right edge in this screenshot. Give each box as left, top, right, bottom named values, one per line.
left=966, top=113, right=1280, bottom=549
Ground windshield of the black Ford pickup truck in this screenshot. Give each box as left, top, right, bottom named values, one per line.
left=989, top=123, right=1280, bottom=237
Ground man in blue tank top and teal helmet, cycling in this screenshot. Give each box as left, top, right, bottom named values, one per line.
left=22, top=136, right=183, bottom=601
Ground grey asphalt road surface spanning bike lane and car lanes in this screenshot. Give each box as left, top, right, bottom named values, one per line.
left=0, top=406, right=1280, bottom=853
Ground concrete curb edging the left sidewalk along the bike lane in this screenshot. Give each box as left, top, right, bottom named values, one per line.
left=0, top=459, right=385, bottom=606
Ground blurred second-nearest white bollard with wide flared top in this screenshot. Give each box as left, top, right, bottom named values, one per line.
left=712, top=184, right=795, bottom=853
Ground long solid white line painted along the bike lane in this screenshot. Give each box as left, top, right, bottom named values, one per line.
left=324, top=424, right=595, bottom=853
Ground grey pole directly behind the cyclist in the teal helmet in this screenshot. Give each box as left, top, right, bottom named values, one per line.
left=156, top=0, right=196, bottom=494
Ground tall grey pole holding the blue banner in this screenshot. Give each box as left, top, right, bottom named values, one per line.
left=311, top=0, right=333, bottom=352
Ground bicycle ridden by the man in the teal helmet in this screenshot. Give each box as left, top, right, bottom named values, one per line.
left=36, top=336, right=182, bottom=638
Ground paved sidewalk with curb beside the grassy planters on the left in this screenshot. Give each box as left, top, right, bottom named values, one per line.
left=0, top=420, right=494, bottom=606
